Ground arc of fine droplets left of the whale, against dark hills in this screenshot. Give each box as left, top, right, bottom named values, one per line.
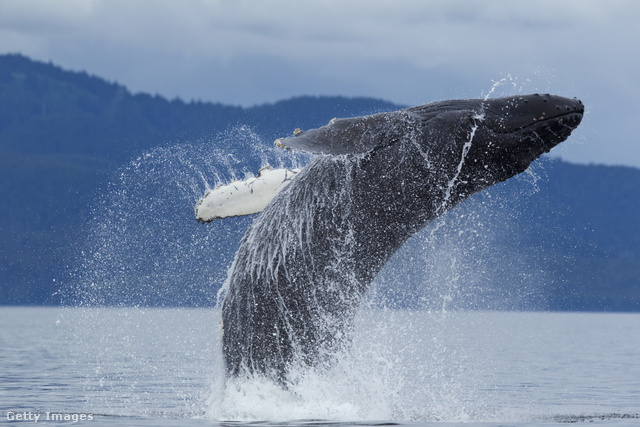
left=65, top=127, right=304, bottom=306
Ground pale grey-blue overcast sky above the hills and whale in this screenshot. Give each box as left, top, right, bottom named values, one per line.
left=0, top=0, right=640, bottom=167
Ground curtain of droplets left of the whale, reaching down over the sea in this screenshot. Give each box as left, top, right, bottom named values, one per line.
left=61, top=127, right=306, bottom=416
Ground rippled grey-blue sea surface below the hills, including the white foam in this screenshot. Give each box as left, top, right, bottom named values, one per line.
left=0, top=307, right=640, bottom=426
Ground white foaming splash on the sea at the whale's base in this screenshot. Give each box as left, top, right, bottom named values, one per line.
left=205, top=310, right=516, bottom=424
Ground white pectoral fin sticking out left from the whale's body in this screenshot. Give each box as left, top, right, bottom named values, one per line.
left=195, top=166, right=300, bottom=222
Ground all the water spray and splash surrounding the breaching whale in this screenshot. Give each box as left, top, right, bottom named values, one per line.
left=57, top=83, right=560, bottom=421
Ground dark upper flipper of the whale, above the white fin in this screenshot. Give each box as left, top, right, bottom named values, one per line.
left=274, top=110, right=412, bottom=155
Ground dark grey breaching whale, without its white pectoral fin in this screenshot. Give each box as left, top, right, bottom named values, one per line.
left=196, top=94, right=584, bottom=384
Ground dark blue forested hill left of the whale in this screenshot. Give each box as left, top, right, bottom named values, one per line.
left=0, top=55, right=397, bottom=304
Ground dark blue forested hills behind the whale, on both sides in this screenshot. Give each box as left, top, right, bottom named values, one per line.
left=0, top=55, right=640, bottom=310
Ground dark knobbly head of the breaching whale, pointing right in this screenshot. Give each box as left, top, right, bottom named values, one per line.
left=403, top=94, right=584, bottom=198
